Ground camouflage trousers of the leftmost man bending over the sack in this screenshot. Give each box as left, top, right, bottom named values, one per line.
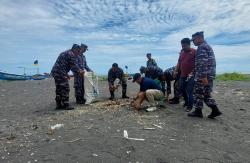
left=54, top=77, right=70, bottom=104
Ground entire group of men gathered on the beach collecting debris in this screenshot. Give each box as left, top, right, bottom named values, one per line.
left=51, top=32, right=222, bottom=119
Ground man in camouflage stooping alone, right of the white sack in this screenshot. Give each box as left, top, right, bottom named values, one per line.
left=108, top=63, right=129, bottom=100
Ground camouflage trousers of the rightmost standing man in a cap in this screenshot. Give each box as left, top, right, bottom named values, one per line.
left=194, top=79, right=216, bottom=109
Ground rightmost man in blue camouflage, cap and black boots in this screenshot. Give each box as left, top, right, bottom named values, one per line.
left=188, top=32, right=222, bottom=119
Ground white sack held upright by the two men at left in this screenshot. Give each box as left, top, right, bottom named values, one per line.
left=84, top=72, right=99, bottom=104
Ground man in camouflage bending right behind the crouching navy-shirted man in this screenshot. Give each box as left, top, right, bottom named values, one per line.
left=140, top=66, right=166, bottom=94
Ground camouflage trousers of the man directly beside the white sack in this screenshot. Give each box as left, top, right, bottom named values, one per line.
left=74, top=75, right=84, bottom=99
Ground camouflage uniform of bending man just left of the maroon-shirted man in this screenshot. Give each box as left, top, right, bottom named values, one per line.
left=163, top=66, right=180, bottom=97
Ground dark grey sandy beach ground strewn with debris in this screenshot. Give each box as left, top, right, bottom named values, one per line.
left=0, top=79, right=250, bottom=163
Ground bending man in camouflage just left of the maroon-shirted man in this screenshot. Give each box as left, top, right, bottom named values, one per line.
left=162, top=66, right=179, bottom=101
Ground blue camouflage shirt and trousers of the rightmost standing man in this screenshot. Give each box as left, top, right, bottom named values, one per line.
left=194, top=41, right=216, bottom=109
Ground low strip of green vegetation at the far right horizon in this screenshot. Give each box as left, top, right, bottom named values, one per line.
left=216, top=72, right=250, bottom=81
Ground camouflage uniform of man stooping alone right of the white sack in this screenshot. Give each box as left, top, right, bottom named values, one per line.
left=108, top=67, right=127, bottom=96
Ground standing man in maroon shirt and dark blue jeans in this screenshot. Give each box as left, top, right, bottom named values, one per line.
left=173, top=38, right=196, bottom=112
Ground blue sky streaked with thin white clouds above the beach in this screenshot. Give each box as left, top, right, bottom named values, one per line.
left=0, top=0, right=250, bottom=74
